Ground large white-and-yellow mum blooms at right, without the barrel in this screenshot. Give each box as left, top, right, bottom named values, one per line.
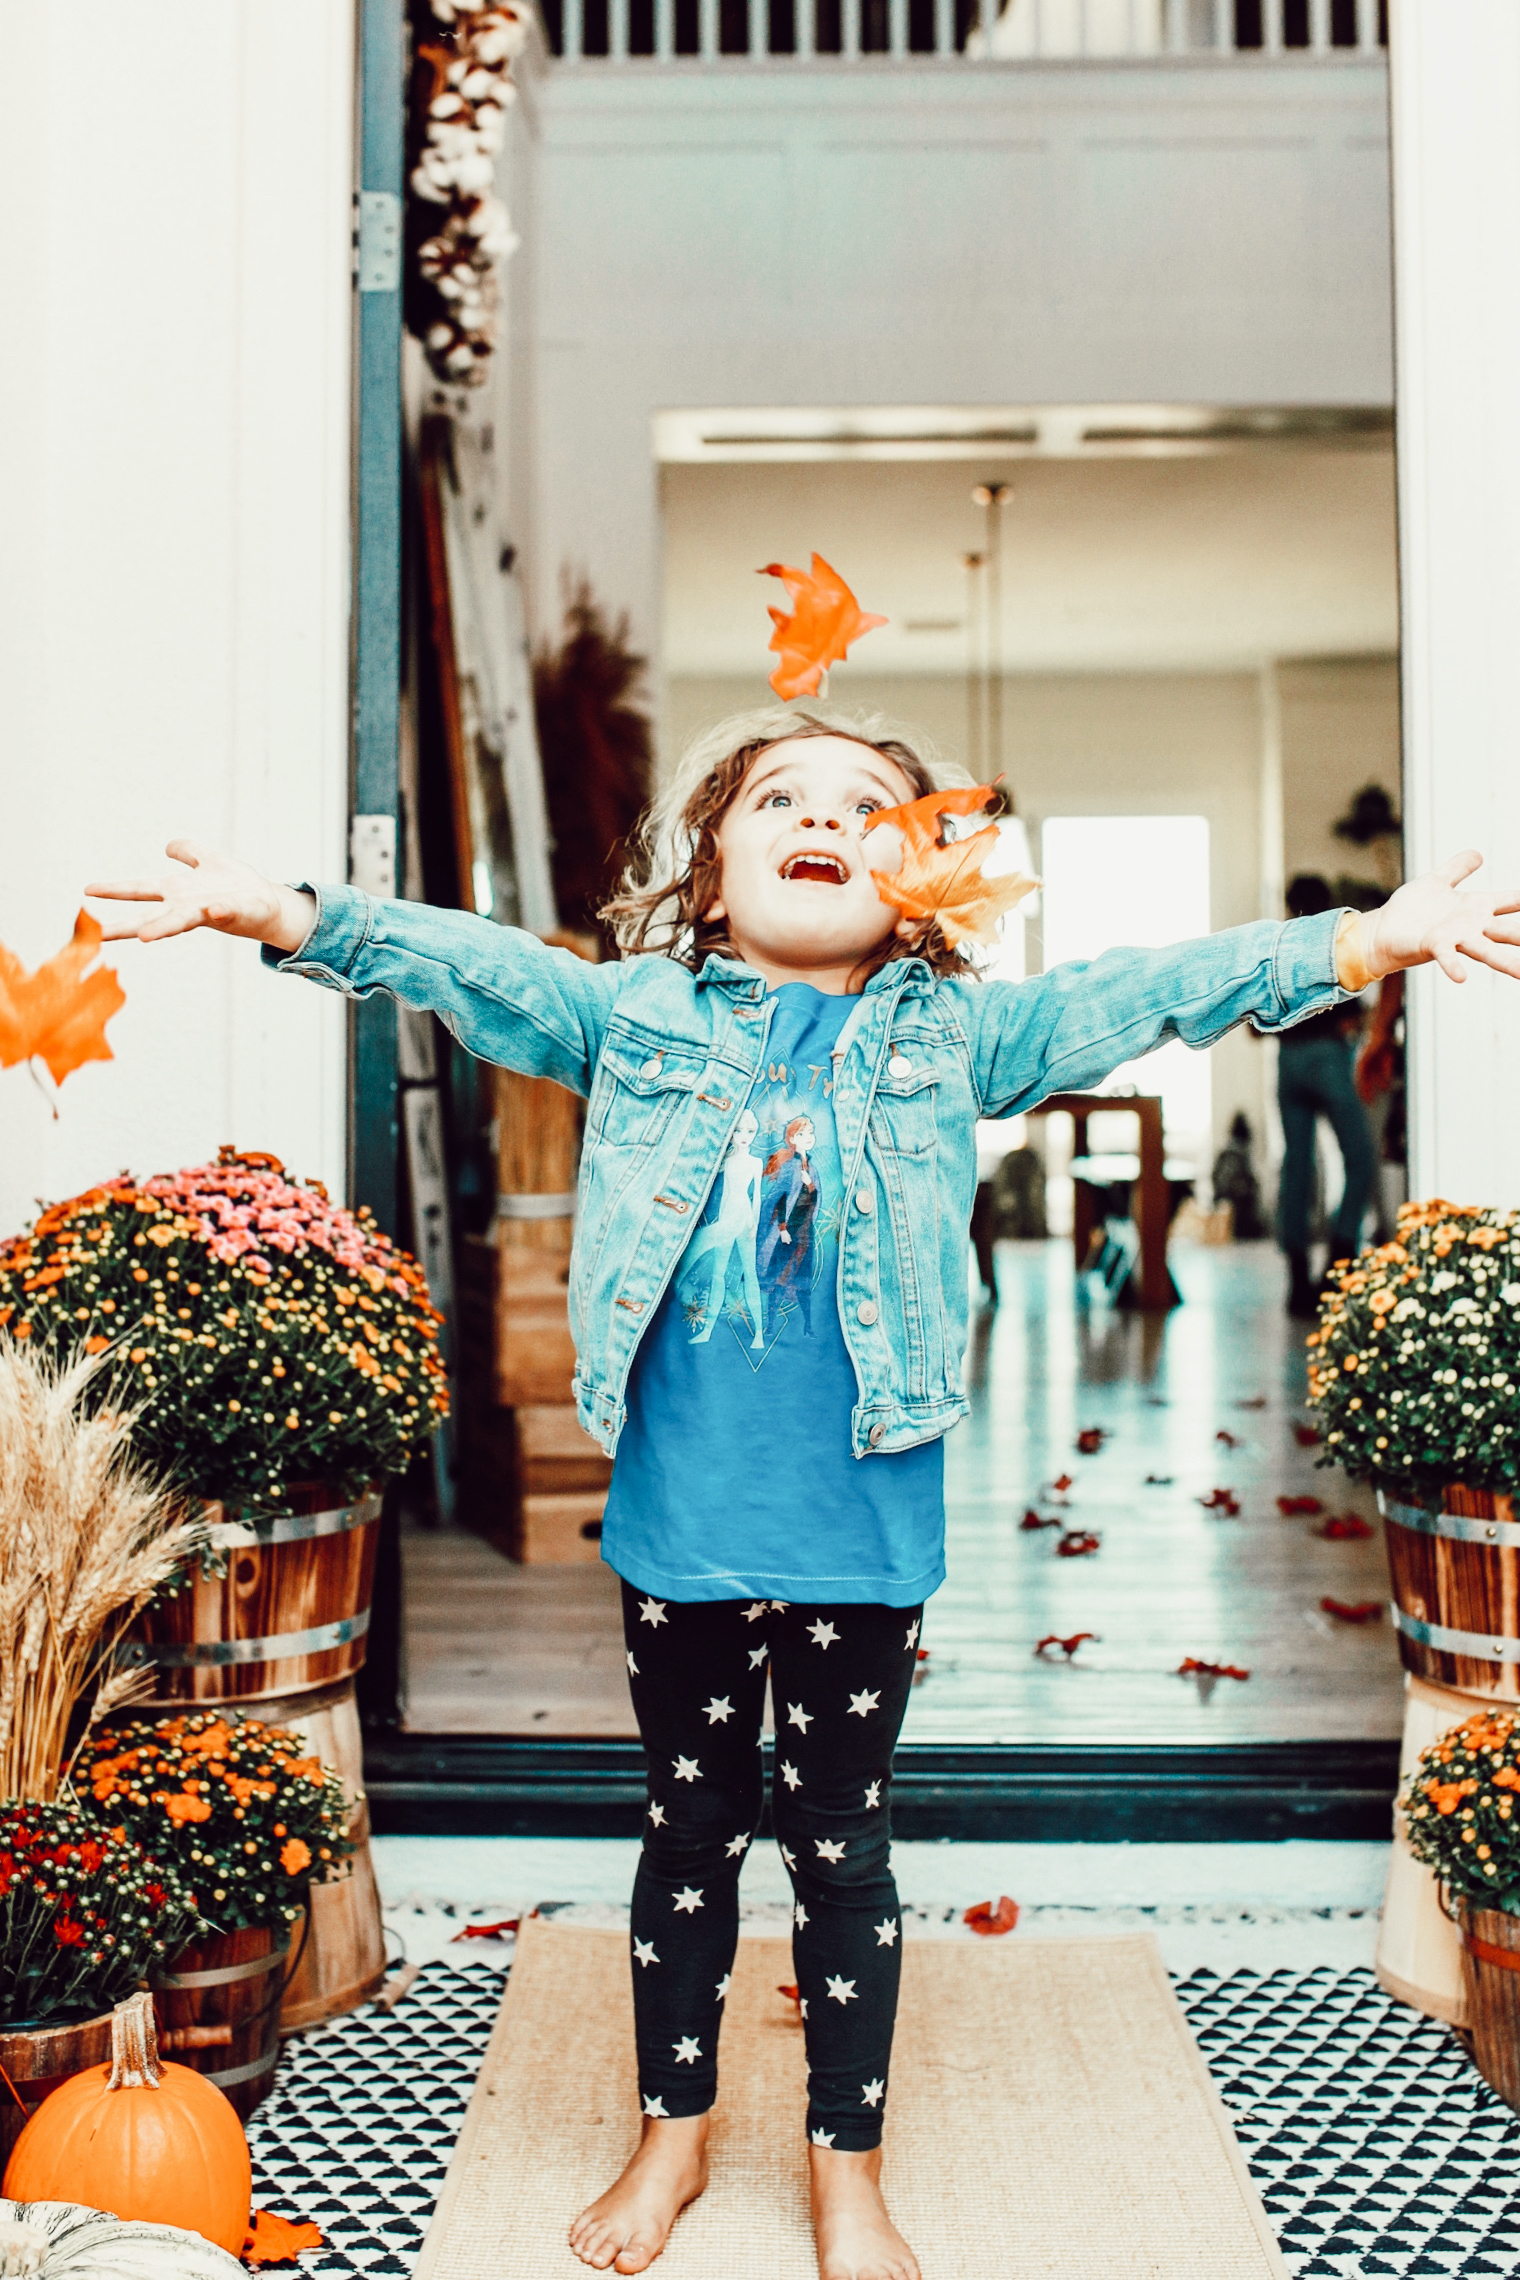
left=1308, top=1202, right=1520, bottom=1498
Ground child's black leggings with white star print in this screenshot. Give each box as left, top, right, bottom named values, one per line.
left=622, top=1582, right=923, bottom=2152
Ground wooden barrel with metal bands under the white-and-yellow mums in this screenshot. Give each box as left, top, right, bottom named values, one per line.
left=1379, top=1487, right=1520, bottom=1703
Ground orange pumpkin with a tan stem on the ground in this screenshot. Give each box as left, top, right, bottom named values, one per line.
left=5, top=1995, right=253, bottom=2255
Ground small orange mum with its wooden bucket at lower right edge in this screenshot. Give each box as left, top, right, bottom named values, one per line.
left=1399, top=1708, right=1520, bottom=2111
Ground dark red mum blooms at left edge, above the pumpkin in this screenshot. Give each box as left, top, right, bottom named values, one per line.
left=0, top=1803, right=198, bottom=2025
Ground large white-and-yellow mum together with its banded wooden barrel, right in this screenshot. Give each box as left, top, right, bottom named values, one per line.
left=1308, top=1202, right=1520, bottom=1699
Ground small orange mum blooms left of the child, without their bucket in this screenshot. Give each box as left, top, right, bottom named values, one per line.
left=75, top=1710, right=353, bottom=1931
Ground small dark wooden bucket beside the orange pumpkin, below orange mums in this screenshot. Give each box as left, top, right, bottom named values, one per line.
left=153, top=1929, right=289, bottom=2120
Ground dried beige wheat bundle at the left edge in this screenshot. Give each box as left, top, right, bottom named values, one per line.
left=0, top=1338, right=205, bottom=1803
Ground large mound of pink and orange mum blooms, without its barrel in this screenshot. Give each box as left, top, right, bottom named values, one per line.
left=0, top=1149, right=449, bottom=1507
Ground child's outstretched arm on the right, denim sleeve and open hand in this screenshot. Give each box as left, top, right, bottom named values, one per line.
left=962, top=850, right=1520, bottom=1117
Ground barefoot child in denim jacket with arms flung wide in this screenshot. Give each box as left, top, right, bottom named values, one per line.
left=89, top=707, right=1520, bottom=2280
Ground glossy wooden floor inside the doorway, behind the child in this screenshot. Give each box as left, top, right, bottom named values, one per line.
left=406, top=1243, right=1401, bottom=1742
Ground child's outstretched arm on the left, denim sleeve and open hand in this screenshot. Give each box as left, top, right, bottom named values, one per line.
left=84, top=839, right=622, bottom=1092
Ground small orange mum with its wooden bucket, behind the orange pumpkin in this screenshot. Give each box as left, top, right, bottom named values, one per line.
left=75, top=1710, right=353, bottom=2118
